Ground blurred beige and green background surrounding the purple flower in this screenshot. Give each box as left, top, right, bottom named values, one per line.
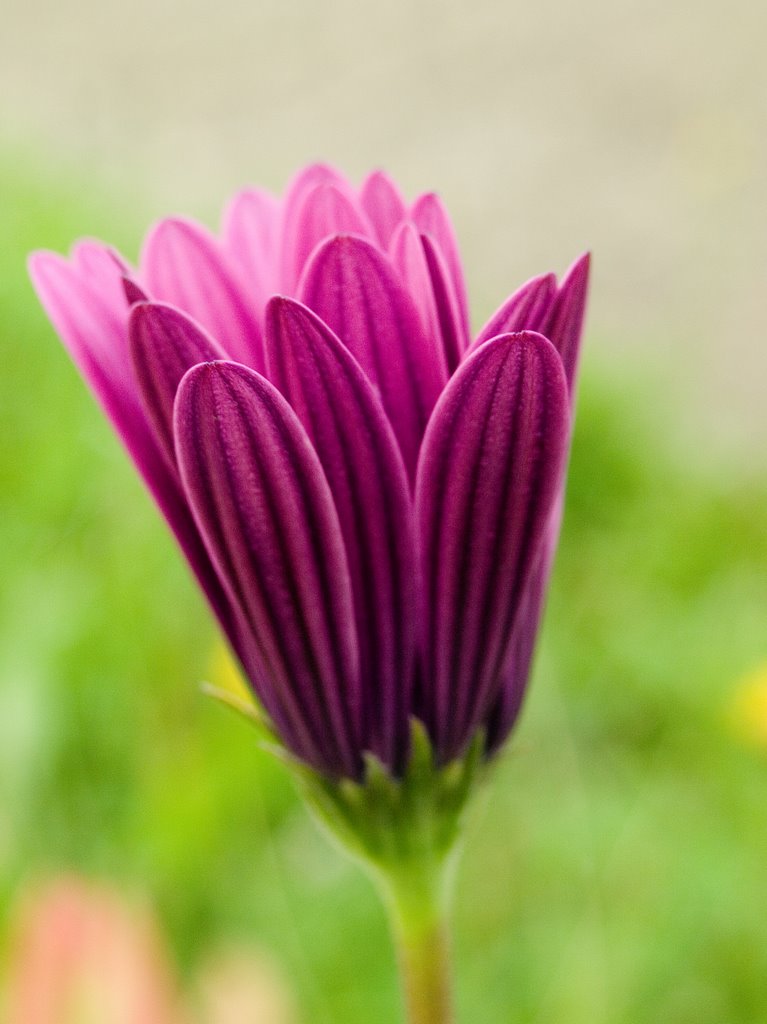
left=0, top=0, right=767, bottom=1024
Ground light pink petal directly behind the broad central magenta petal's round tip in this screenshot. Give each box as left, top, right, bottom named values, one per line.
left=283, top=184, right=373, bottom=292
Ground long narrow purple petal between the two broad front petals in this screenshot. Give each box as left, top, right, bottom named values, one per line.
left=266, top=298, right=416, bottom=769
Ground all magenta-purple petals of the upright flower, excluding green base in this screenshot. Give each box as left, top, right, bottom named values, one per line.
left=30, top=166, right=588, bottom=778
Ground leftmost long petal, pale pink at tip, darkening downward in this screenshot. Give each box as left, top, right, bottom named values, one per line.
left=30, top=252, right=240, bottom=634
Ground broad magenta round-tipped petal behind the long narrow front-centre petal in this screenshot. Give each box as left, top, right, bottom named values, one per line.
left=300, top=236, right=444, bottom=478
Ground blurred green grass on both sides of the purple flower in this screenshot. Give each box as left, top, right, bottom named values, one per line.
left=0, top=153, right=767, bottom=1024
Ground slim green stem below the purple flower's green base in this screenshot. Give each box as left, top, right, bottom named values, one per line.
left=384, top=864, right=455, bottom=1024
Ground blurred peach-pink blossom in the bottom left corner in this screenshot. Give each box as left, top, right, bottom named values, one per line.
left=3, top=876, right=295, bottom=1024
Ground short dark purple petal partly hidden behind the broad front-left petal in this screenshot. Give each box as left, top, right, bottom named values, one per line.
left=128, top=302, right=225, bottom=467
